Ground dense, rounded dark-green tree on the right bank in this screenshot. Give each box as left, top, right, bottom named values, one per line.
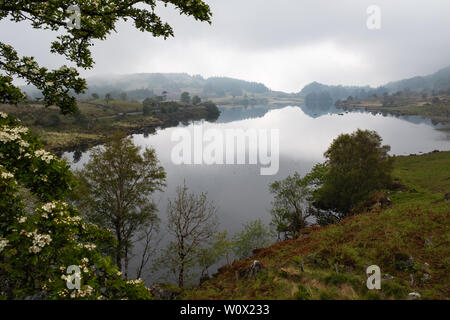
left=314, top=129, right=392, bottom=216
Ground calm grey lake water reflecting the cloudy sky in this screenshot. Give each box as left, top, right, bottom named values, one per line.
left=64, top=106, right=450, bottom=282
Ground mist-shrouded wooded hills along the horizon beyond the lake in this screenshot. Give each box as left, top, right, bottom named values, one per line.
left=24, top=66, right=450, bottom=101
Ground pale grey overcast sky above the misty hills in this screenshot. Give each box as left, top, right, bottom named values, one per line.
left=0, top=0, right=450, bottom=92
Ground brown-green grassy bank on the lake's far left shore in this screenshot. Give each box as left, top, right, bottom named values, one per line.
left=0, top=99, right=217, bottom=153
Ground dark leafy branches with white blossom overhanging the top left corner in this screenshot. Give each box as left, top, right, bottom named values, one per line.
left=0, top=0, right=211, bottom=114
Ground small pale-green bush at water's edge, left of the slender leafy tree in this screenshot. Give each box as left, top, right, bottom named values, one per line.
left=233, top=219, right=273, bottom=259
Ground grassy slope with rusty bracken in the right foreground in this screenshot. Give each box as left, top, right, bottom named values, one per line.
left=183, top=152, right=450, bottom=300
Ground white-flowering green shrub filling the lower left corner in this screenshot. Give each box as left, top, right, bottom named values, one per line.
left=0, top=112, right=151, bottom=299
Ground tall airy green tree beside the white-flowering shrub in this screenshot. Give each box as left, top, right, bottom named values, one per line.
left=76, top=133, right=166, bottom=277
